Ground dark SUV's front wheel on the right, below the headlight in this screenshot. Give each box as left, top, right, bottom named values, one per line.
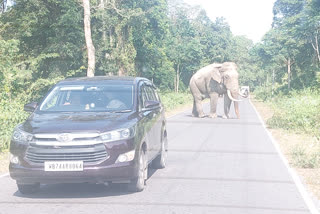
left=128, top=151, right=148, bottom=192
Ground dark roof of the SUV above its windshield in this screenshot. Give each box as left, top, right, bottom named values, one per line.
left=57, top=76, right=151, bottom=85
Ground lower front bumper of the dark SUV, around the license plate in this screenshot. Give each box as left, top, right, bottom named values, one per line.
left=9, top=161, right=138, bottom=184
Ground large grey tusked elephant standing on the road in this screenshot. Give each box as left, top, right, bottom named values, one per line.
left=189, top=62, right=245, bottom=118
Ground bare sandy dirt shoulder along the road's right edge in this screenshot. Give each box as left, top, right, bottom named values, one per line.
left=251, top=99, right=320, bottom=200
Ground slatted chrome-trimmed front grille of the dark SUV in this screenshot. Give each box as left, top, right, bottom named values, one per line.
left=25, top=144, right=109, bottom=164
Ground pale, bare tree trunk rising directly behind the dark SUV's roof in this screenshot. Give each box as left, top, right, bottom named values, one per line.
left=82, top=0, right=96, bottom=77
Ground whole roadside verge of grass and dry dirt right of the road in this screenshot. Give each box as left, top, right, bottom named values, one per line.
left=253, top=92, right=320, bottom=199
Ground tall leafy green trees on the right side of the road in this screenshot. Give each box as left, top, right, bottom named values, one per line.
left=254, top=0, right=320, bottom=93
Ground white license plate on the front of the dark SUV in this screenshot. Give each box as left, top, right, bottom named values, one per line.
left=44, top=161, right=83, bottom=172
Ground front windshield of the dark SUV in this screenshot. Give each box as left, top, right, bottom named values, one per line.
left=40, top=85, right=133, bottom=112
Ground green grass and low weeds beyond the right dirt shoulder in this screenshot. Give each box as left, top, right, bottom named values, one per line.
left=255, top=89, right=320, bottom=168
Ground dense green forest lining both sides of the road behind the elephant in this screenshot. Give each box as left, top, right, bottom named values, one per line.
left=0, top=0, right=320, bottom=151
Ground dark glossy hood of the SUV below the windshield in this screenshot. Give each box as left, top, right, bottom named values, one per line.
left=23, top=112, right=135, bottom=134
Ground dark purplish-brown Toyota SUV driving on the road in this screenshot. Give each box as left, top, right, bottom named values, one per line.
left=10, top=77, right=167, bottom=193
